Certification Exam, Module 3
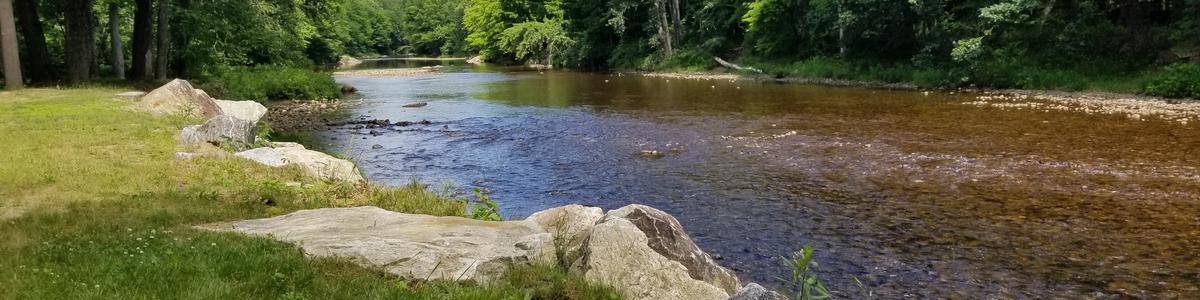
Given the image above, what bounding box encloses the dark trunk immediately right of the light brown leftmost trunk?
[13,0,54,83]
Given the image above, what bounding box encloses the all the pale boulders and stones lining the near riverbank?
[126,79,782,300]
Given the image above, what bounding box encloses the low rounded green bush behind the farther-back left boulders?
[204,66,341,102]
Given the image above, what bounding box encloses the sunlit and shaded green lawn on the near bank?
[0,88,616,299]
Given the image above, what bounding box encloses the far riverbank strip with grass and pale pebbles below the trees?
[646,58,1200,98]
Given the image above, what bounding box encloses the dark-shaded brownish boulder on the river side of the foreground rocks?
[605,204,742,294]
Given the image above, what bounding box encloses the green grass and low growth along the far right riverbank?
[653,52,1200,98]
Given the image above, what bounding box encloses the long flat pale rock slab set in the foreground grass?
[202,206,553,282]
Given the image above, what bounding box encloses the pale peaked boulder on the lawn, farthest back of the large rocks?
[138,79,221,118]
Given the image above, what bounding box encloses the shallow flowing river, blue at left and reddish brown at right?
[320,62,1200,299]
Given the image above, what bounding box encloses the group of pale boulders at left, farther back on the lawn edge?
[125,79,365,182]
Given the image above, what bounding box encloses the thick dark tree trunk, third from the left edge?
[62,0,96,84]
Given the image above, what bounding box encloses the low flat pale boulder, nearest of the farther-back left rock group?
[234,143,366,182]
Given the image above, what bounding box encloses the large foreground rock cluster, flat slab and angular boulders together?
[202,204,784,300]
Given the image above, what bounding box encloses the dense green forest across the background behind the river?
[2,0,1200,96]
